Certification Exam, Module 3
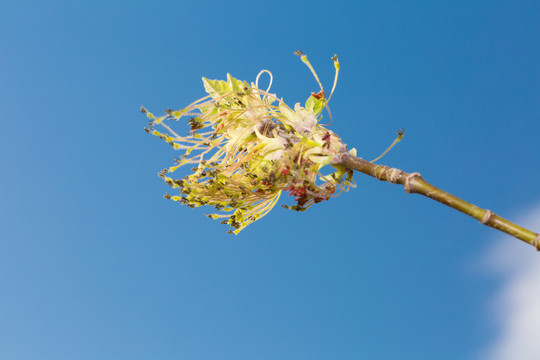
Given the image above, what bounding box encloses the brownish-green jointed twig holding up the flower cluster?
[341,154,540,250]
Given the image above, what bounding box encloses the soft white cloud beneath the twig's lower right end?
[483,202,540,360]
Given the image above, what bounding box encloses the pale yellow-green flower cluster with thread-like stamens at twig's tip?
[141,53,355,234]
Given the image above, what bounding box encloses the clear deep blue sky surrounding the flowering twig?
[0,0,540,360]
